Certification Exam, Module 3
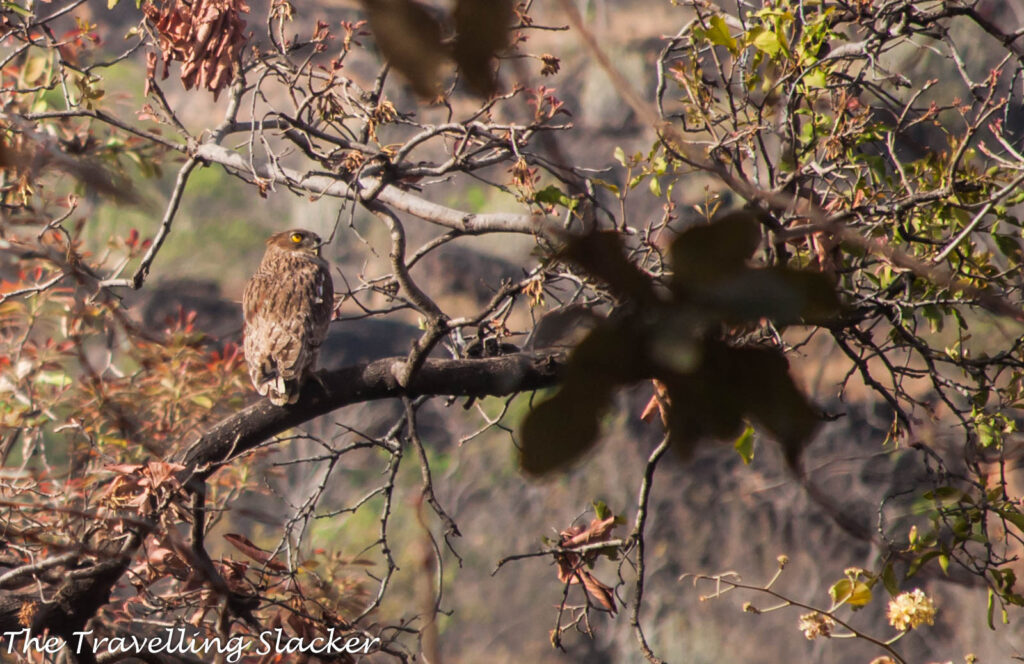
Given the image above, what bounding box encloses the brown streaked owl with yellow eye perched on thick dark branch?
[242,230,334,406]
